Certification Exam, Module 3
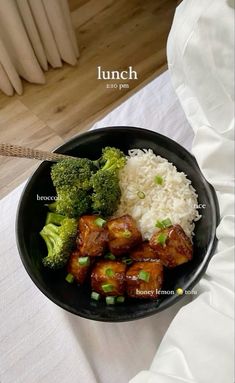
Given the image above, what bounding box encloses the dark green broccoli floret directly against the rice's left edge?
[92,169,121,217]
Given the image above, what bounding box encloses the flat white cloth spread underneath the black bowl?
[0,72,193,383]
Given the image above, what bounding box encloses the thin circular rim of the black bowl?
[15,125,220,323]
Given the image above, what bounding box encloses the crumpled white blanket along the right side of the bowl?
[131,0,234,383]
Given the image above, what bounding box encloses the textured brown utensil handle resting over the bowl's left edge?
[0,144,76,162]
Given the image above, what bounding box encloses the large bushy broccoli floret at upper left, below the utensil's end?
[49,158,95,218]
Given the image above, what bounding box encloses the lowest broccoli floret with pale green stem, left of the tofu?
[40,213,77,269]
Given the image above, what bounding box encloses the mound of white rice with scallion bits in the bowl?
[115,149,200,239]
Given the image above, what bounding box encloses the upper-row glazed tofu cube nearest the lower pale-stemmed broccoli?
[77,215,108,257]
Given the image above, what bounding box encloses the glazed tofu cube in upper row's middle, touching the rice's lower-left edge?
[106,214,142,256]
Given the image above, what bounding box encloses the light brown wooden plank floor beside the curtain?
[0,0,177,198]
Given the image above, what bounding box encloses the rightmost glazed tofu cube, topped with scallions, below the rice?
[150,225,193,268]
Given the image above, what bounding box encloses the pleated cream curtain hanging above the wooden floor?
[0,0,79,96]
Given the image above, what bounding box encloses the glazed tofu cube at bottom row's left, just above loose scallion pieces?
[91,260,126,296]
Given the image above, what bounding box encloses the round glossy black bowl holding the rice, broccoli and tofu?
[16,127,219,322]
